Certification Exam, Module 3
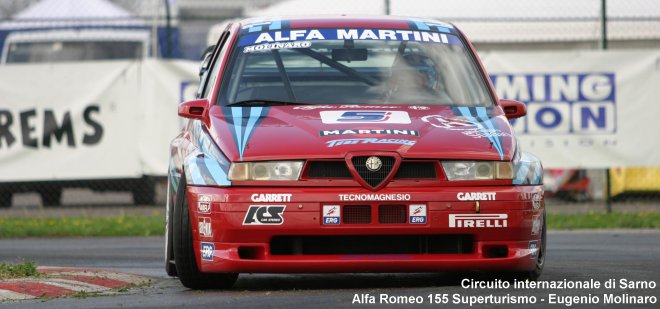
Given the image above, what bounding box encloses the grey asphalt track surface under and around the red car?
[0,230,660,309]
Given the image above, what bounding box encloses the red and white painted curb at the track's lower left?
[0,266,150,301]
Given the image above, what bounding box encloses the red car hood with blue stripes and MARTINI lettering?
[209,105,515,161]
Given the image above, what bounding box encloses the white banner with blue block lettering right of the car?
[480,50,660,168]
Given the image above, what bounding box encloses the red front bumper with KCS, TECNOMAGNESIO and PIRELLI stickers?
[187,186,544,273]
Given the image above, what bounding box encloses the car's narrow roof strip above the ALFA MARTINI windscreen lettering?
[239,15,455,32]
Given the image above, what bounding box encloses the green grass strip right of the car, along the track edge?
[546,212,660,230]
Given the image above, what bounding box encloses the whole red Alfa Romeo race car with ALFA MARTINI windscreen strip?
[166,16,546,289]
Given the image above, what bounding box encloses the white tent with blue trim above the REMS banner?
[0,0,155,64]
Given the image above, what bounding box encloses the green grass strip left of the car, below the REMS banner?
[0,214,165,238]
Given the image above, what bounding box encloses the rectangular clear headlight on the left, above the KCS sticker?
[228,161,303,180]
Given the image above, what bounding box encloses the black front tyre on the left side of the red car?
[172,177,238,290]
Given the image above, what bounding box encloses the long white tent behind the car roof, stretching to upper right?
[246,0,660,43]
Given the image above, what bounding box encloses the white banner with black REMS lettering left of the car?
[0,60,199,182]
